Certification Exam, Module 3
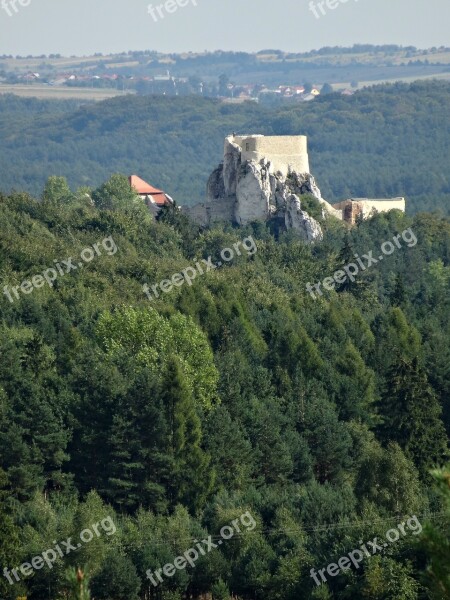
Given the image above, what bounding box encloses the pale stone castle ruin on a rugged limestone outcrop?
[183,134,405,241]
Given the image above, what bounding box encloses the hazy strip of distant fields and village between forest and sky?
[0,44,450,104]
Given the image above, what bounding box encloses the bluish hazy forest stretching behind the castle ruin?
[0,82,450,214]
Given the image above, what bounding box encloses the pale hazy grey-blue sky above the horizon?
[0,0,450,55]
